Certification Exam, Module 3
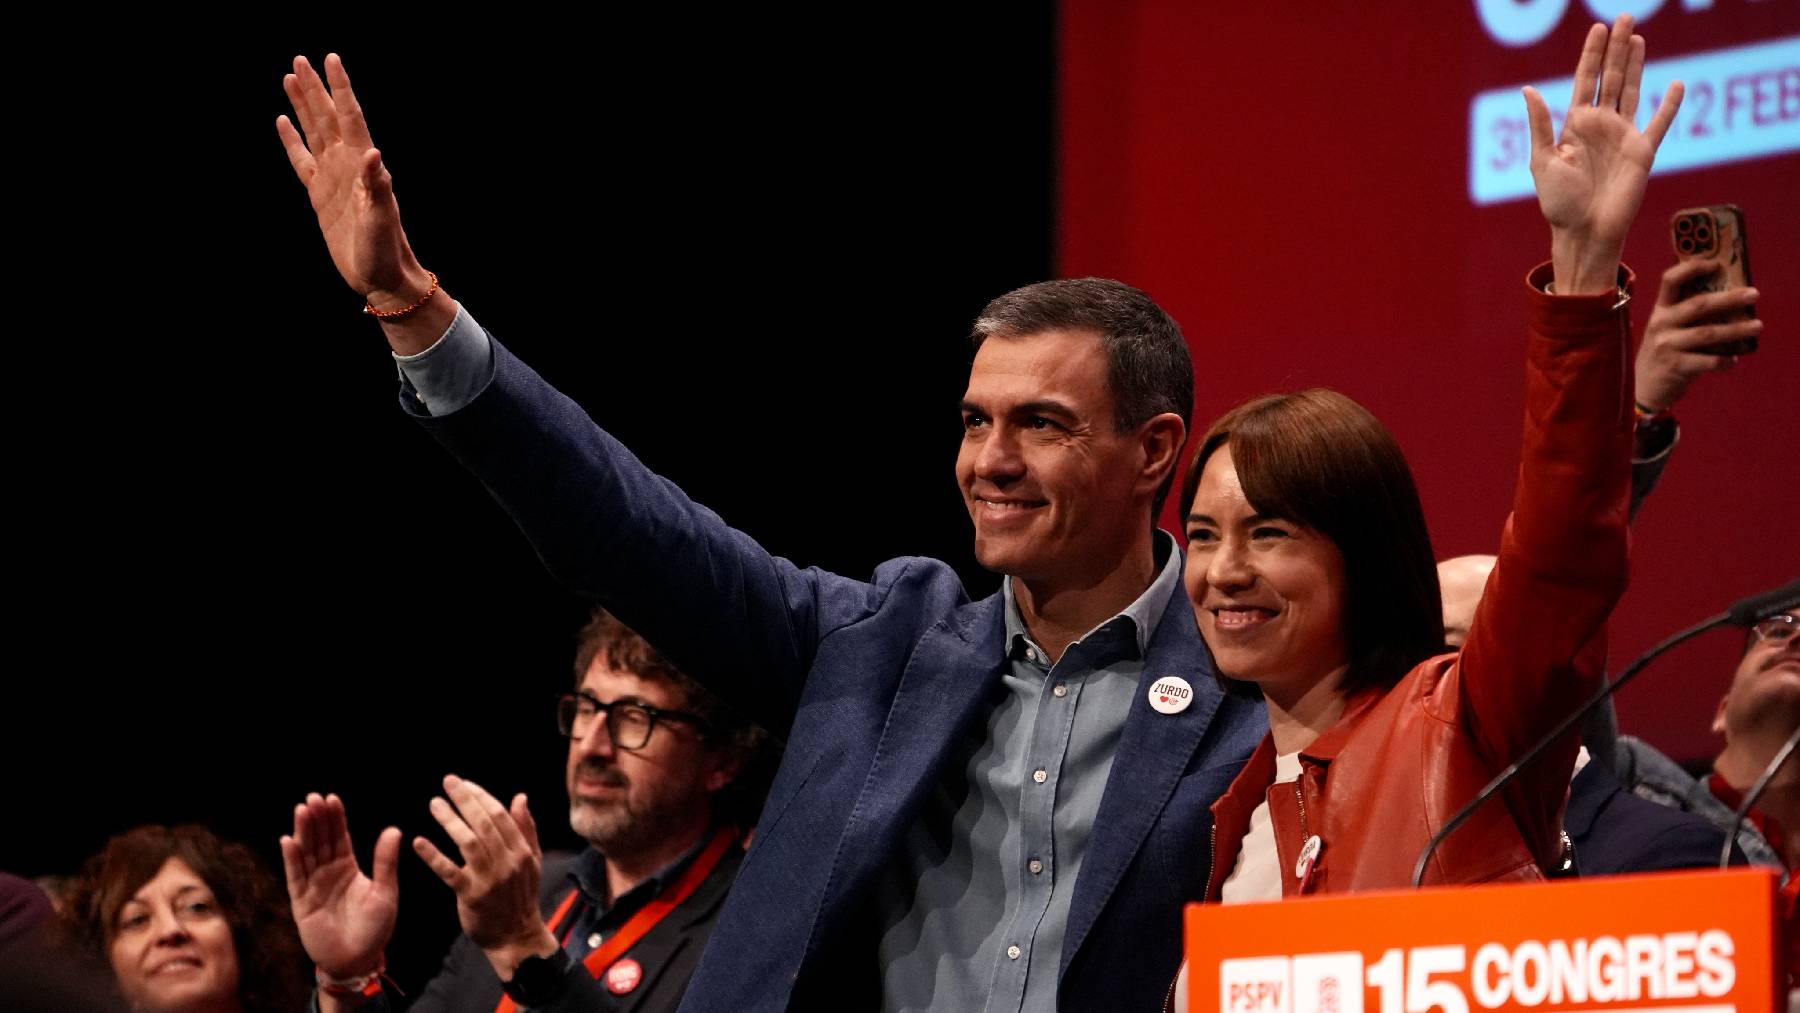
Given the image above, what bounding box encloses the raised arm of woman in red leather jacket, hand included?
[1458,16,1681,862]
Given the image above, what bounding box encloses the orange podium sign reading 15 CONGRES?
[1186,869,1786,1013]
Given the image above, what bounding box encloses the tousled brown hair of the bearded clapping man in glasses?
[574,608,781,828]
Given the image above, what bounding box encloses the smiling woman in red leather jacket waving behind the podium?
[1183,16,1681,903]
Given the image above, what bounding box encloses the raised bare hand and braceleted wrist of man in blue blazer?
[275,52,457,354]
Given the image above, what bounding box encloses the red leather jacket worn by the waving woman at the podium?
[1206,264,1633,900]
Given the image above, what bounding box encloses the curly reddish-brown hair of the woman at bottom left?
[61,824,311,1013]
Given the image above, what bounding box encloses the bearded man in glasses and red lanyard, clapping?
[281,610,770,1013]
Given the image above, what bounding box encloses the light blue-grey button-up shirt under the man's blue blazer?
[878,531,1181,1013]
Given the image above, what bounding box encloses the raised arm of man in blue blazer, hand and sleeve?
[275,54,849,731]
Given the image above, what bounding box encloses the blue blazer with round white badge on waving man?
[412,342,1267,1013]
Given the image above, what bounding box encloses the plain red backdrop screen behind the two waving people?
[1058,0,1800,759]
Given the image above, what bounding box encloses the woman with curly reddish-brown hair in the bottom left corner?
[61,824,311,1013]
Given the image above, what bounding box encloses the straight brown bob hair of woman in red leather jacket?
[1181,389,1444,696]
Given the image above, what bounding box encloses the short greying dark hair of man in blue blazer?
[968,277,1193,516]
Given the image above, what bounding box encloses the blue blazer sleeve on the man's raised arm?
[400,342,878,734]
